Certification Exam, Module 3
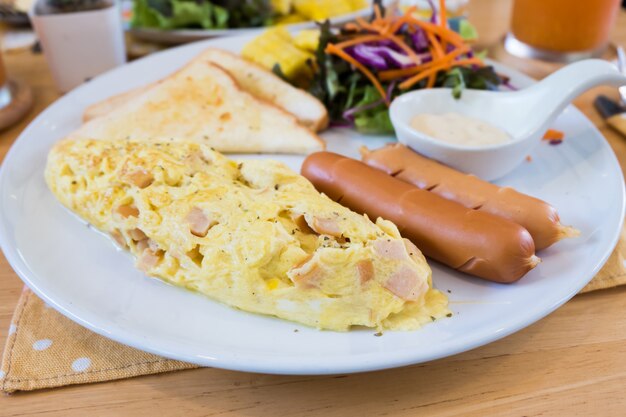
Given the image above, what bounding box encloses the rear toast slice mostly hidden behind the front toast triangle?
[83,48,328,132]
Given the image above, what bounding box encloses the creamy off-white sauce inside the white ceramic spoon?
[410,113,511,148]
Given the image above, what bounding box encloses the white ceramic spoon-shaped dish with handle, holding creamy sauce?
[389,59,626,181]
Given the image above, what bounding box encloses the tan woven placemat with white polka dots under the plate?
[0,226,626,393]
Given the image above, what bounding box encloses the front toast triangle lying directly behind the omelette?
[70,60,324,154]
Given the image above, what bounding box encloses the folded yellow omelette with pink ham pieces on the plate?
[45,139,449,331]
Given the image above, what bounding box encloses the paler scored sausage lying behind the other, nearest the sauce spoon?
[361,143,580,250]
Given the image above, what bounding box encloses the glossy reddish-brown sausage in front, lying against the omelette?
[302,152,540,283]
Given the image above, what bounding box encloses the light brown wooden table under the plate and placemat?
[0,0,626,417]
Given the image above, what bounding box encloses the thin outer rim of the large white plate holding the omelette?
[0,34,626,375]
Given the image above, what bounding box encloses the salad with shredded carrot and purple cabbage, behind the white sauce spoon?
[243,0,505,133]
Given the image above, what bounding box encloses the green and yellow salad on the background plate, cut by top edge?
[131,0,367,29]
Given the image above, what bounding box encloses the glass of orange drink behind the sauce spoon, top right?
[505,0,621,62]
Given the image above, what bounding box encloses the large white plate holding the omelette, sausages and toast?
[0,37,624,374]
